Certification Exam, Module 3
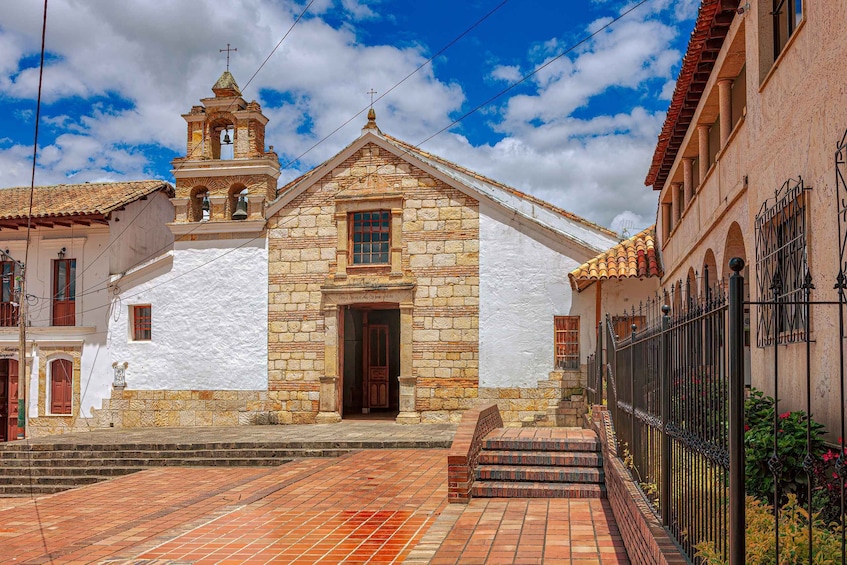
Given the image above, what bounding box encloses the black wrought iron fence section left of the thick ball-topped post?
[595,285,729,556]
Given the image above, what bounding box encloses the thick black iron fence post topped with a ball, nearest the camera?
[728,257,745,565]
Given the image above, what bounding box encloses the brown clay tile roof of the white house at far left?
[0,180,174,229]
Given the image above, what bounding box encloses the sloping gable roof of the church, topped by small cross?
[274,124,617,256]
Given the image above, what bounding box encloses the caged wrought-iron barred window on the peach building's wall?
[756,179,808,347]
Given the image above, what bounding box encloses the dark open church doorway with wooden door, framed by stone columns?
[340,304,400,418]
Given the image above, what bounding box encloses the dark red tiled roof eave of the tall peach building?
[644,0,739,190]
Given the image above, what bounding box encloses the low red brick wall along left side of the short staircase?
[447,404,503,503]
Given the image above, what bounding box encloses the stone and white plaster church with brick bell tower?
[1,71,618,434]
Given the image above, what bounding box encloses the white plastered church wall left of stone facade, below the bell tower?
[109,237,268,390]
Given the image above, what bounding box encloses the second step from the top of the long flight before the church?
[0,448,353,465]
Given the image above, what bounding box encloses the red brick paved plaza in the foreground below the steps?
[0,440,628,564]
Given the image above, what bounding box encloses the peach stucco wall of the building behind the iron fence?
[658,0,847,437]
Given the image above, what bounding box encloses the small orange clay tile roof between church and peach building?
[568,225,663,291]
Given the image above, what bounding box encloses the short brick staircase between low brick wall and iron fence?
[471,428,606,498]
